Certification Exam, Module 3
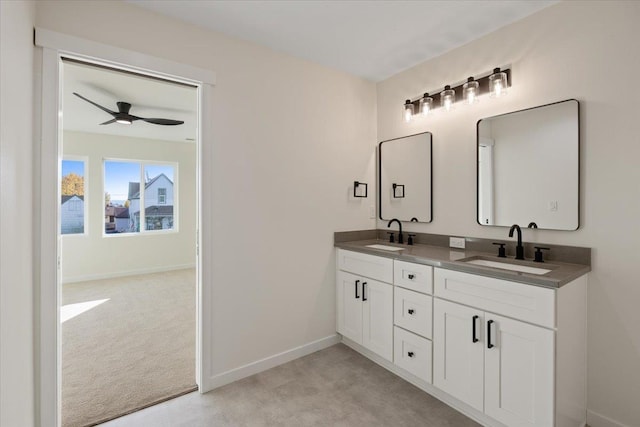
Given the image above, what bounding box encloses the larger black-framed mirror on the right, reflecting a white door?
[477,99,580,230]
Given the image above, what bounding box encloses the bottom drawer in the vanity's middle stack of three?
[393,326,432,384]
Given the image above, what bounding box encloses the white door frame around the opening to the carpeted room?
[34,28,216,427]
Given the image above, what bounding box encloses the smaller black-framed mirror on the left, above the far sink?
[378,132,432,222]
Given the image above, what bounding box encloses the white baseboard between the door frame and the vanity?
[200,334,340,393]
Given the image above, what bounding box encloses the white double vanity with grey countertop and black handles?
[335,230,590,427]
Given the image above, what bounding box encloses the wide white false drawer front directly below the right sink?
[433,268,556,328]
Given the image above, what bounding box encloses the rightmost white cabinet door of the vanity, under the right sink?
[485,313,554,427]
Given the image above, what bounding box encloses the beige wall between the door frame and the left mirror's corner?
[36,1,377,402]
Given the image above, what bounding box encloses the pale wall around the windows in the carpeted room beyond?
[62,131,196,283]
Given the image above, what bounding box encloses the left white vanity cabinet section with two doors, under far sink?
[337,249,393,361]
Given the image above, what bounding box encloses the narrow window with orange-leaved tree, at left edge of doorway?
[60,159,86,234]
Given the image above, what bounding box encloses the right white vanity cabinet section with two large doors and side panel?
[433,268,586,427]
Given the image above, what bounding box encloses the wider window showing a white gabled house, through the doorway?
[104,160,177,234]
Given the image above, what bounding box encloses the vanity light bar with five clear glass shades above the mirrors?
[402,68,511,122]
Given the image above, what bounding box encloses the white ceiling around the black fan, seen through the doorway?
[62,61,197,142]
